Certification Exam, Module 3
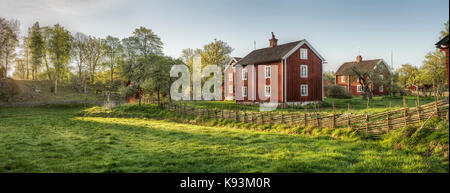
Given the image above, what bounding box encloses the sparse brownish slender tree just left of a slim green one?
[86,36,105,85]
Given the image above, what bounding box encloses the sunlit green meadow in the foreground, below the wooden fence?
[0,108,448,172]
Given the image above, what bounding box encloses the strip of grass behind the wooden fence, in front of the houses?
[179,96,440,113]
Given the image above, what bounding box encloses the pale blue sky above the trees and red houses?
[0,0,449,70]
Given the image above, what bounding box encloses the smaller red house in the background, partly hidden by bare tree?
[335,56,389,95]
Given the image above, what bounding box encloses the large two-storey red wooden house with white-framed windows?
[225,33,325,104]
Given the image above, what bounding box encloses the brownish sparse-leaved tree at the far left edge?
[0,18,19,77]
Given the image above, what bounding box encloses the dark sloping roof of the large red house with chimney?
[237,40,302,65]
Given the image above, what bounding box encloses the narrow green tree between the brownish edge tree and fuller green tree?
[28,22,44,80]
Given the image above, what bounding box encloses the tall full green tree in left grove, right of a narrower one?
[49,24,72,94]
